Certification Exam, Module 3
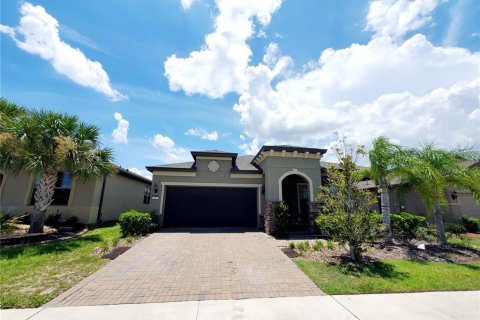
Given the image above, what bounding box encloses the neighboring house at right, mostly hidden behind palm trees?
[361,161,480,223]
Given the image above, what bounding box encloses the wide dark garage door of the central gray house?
[163,187,257,228]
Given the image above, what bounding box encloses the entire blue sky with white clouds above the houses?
[0,0,480,178]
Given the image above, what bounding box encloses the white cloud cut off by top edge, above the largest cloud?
[367,0,440,38]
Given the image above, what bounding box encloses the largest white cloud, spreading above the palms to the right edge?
[234,35,480,149]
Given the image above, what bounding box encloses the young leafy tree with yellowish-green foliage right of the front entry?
[316,138,384,261]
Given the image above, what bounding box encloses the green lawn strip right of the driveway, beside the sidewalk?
[294,259,480,294]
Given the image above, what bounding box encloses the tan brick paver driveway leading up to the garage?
[47,231,323,306]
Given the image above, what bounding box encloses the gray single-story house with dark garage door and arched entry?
[147,146,326,233]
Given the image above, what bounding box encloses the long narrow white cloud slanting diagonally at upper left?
[0,2,127,101]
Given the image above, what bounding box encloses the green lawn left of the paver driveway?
[0,226,120,308]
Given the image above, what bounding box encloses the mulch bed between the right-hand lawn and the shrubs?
[282,242,480,264]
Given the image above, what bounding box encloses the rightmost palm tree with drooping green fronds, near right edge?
[397,142,480,244]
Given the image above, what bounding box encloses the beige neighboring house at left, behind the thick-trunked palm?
[0,167,151,224]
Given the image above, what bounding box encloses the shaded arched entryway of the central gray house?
[279,172,312,231]
